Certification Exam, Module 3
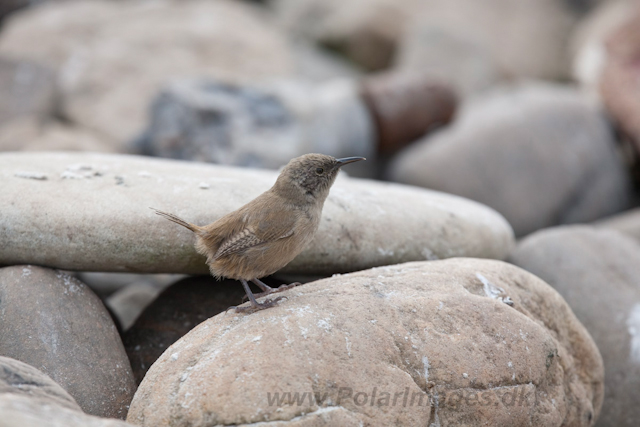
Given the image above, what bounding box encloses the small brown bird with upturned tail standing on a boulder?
[156,154,365,312]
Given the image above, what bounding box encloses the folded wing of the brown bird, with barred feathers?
[215,202,296,258]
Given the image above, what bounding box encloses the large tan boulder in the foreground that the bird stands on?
[127,259,603,427]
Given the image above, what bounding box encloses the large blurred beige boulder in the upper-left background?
[0,0,294,149]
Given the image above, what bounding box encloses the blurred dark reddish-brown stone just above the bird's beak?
[361,72,458,155]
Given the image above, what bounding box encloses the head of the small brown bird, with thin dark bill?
[274,154,365,202]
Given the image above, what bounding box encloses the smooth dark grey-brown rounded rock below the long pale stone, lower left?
[0,266,135,418]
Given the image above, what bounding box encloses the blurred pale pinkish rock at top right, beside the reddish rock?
[570,0,636,97]
